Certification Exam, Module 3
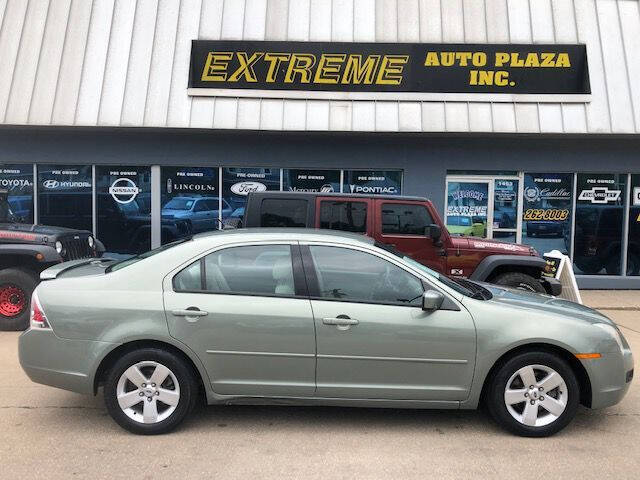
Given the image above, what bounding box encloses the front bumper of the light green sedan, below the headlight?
[581,349,633,408]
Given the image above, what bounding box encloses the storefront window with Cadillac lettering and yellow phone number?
[522,173,573,255]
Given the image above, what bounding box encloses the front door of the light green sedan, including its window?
[301,244,476,401]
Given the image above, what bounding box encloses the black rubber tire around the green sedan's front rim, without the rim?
[485,352,580,437]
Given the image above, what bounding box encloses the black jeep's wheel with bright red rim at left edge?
[0,268,38,331]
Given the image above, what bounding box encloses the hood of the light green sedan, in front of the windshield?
[475,282,613,325]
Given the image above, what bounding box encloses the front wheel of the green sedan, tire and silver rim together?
[486,352,580,437]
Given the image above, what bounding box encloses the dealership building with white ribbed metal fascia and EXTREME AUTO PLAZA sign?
[0,0,640,288]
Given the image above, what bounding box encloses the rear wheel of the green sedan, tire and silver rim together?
[104,348,198,435]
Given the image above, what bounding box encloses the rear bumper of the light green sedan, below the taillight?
[18,329,116,394]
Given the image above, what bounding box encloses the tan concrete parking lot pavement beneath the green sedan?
[0,311,640,479]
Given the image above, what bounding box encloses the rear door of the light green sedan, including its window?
[164,243,316,396]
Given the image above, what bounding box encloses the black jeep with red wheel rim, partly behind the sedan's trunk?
[0,190,104,330]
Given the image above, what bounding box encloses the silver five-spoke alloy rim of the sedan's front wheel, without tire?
[504,365,568,427]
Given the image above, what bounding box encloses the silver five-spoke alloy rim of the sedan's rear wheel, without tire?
[116,361,180,424]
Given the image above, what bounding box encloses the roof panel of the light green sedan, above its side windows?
[193,228,375,245]
